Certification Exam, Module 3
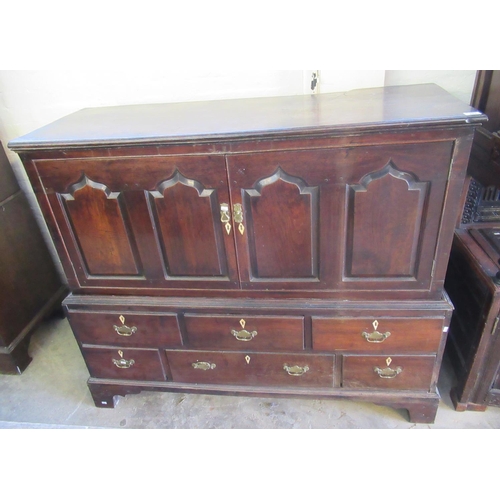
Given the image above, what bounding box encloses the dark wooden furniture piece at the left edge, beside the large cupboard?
[0,144,66,374]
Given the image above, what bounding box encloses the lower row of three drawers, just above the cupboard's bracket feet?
[82,347,436,390]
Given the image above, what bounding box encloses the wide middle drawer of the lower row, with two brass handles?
[167,351,334,387]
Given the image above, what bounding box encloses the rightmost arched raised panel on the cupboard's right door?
[345,161,428,280]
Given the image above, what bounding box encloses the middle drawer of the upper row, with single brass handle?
[185,314,304,351]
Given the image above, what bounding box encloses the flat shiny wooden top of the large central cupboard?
[9,84,487,151]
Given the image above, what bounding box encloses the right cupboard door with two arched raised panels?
[228,141,453,291]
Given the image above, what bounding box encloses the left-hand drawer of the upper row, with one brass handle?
[68,312,182,347]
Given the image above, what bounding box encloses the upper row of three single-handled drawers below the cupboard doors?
[69,312,443,352]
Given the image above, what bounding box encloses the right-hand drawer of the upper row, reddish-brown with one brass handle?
[312,317,444,352]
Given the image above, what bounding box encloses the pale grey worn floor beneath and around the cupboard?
[0,319,500,429]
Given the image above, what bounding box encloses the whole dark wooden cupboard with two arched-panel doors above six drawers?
[10,84,485,422]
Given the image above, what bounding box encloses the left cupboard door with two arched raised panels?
[35,156,239,289]
